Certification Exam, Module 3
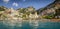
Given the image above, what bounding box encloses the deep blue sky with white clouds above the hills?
[0,0,54,9]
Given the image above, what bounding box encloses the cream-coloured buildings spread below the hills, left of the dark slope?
[1,7,39,20]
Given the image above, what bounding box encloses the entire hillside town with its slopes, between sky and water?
[0,1,60,20]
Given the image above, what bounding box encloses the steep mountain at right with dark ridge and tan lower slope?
[37,0,60,18]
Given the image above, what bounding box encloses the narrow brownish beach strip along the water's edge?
[0,19,60,22]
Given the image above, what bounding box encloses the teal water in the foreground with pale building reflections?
[0,21,60,29]
